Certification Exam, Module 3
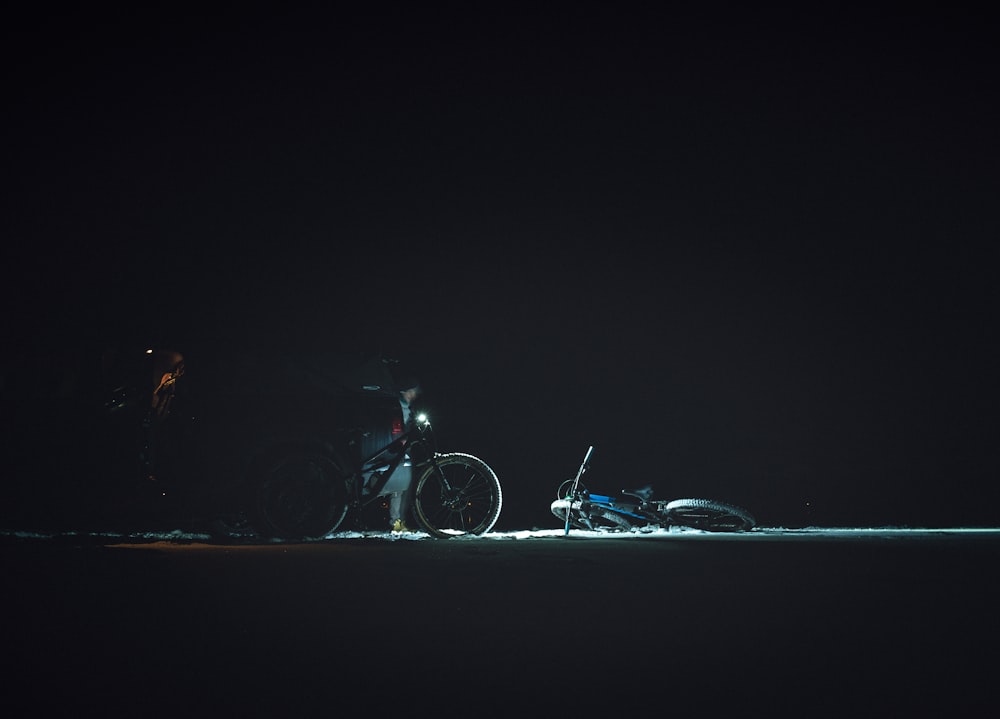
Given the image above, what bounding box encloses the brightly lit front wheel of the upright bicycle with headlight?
[413,452,503,539]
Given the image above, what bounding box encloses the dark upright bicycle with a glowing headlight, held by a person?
[256,415,503,539]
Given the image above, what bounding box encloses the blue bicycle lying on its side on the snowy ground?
[551,447,757,534]
